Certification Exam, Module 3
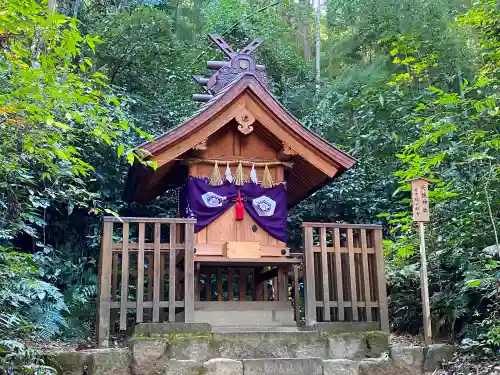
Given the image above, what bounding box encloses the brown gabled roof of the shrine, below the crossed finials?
[124,73,356,205]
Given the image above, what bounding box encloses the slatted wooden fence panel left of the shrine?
[96,217,195,347]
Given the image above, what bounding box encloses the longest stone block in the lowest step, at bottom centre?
[243,358,323,375]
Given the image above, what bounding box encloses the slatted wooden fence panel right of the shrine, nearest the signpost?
[302,223,389,331]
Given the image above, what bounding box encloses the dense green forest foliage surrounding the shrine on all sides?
[0,0,500,362]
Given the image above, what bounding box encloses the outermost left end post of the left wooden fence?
[96,221,113,348]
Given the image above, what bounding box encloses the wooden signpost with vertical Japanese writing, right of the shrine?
[409,178,432,345]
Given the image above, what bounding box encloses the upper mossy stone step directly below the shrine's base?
[130,328,389,363]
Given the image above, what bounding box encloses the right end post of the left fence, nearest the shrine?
[184,223,194,323]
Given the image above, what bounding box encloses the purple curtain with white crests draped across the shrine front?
[179,177,287,242]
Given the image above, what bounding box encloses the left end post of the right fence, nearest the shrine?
[303,226,317,326]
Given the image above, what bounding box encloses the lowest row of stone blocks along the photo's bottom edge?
[46,345,453,375]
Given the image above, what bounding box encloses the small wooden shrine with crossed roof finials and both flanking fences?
[95,35,385,346]
